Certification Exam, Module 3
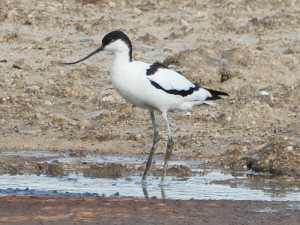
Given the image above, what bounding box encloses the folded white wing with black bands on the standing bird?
[146,63,197,91]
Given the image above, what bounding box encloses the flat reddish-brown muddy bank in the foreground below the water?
[0,196,300,225]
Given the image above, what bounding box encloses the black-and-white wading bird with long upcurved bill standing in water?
[63,30,228,186]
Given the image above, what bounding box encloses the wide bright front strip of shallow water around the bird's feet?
[0,170,300,201]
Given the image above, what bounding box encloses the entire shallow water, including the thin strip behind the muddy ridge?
[0,150,300,201]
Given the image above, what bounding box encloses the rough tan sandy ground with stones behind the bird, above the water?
[0,0,300,224]
